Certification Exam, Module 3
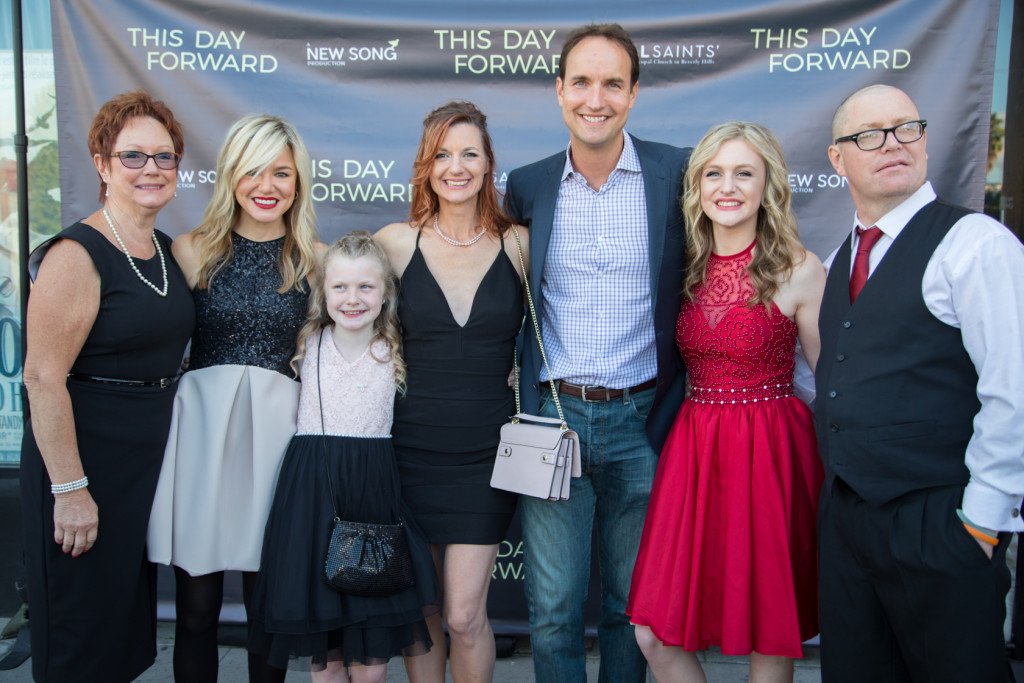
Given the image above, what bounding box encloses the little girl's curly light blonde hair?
[292,230,406,394]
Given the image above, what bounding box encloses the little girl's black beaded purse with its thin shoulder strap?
[316,330,416,597]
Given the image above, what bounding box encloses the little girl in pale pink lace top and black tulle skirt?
[249,230,443,683]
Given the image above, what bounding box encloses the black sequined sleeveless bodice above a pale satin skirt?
[188,232,308,377]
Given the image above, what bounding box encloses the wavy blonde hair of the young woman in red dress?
[682,121,805,306]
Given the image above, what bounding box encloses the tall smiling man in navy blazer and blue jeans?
[506,25,689,683]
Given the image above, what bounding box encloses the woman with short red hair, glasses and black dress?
[22,91,195,683]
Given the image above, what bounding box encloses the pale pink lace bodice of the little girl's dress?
[298,328,394,436]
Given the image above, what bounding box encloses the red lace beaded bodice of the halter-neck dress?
[676,245,797,403]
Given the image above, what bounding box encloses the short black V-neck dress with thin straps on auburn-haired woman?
[391,236,523,545]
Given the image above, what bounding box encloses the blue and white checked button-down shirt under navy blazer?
[541,132,657,389]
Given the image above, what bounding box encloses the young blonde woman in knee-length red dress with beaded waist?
[627,122,825,683]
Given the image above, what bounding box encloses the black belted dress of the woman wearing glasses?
[22,223,196,683]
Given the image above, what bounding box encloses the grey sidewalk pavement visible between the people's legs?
[0,618,821,683]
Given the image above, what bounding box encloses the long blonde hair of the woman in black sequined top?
[193,114,316,294]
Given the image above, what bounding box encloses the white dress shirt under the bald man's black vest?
[825,182,1024,531]
